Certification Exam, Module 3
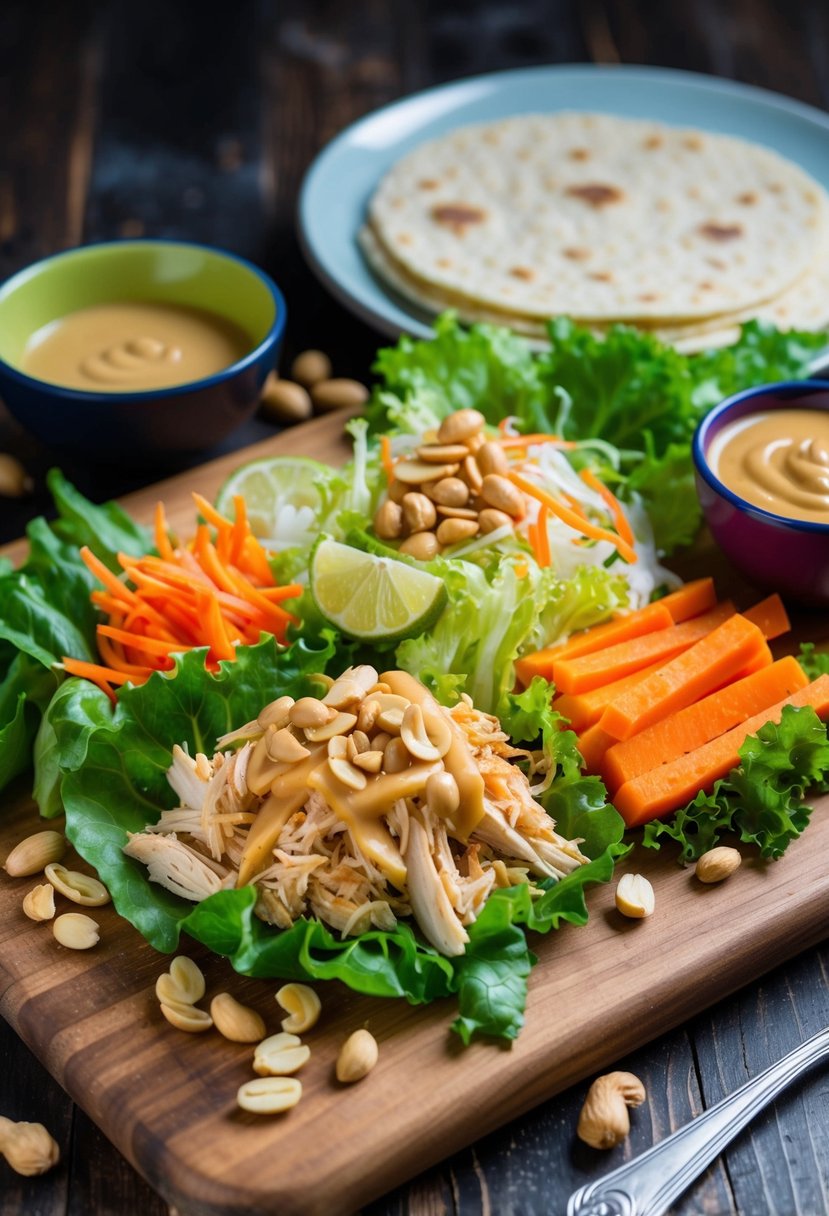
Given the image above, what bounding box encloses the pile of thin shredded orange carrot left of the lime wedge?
[64,494,303,699]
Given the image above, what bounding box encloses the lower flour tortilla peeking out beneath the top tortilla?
[359,227,829,354]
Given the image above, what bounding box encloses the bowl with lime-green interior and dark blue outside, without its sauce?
[0,241,286,463]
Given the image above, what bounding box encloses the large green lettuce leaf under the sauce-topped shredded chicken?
[56,631,621,1040]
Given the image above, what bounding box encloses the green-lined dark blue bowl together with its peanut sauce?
[0,240,286,465]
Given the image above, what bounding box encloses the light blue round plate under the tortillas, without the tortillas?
[299,64,829,338]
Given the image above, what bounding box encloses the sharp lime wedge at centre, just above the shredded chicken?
[310,539,446,642]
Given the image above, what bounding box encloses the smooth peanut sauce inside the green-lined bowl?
[21,300,253,393]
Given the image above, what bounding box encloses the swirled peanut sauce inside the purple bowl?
[709,410,829,524]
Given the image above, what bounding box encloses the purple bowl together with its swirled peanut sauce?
[693,379,829,606]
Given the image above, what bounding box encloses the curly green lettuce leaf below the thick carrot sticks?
[643,705,829,862]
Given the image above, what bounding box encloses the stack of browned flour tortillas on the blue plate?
[360,113,829,350]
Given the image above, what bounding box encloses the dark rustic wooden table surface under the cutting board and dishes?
[0,0,829,1216]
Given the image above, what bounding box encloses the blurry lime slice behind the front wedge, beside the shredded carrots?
[216,456,337,545]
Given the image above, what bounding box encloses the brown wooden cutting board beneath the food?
[0,416,829,1216]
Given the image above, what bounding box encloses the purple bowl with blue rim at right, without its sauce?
[693,381,829,604]
